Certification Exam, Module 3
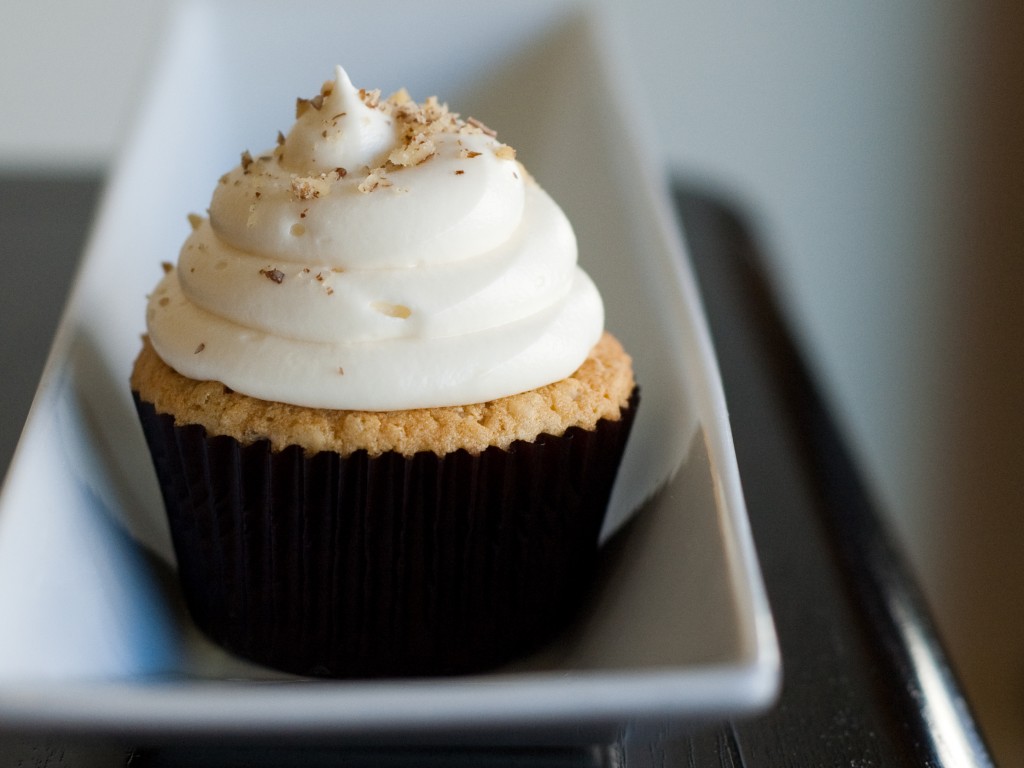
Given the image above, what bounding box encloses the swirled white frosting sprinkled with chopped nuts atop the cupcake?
[147,68,604,411]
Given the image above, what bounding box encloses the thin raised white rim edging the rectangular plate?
[0,2,781,737]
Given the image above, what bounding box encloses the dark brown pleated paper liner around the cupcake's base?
[135,391,638,677]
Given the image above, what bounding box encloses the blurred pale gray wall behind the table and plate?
[0,0,1024,765]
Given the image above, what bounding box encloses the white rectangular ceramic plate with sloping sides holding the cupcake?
[0,1,779,743]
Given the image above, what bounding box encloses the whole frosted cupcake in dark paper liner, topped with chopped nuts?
[131,68,637,677]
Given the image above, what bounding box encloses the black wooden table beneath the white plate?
[0,174,991,768]
